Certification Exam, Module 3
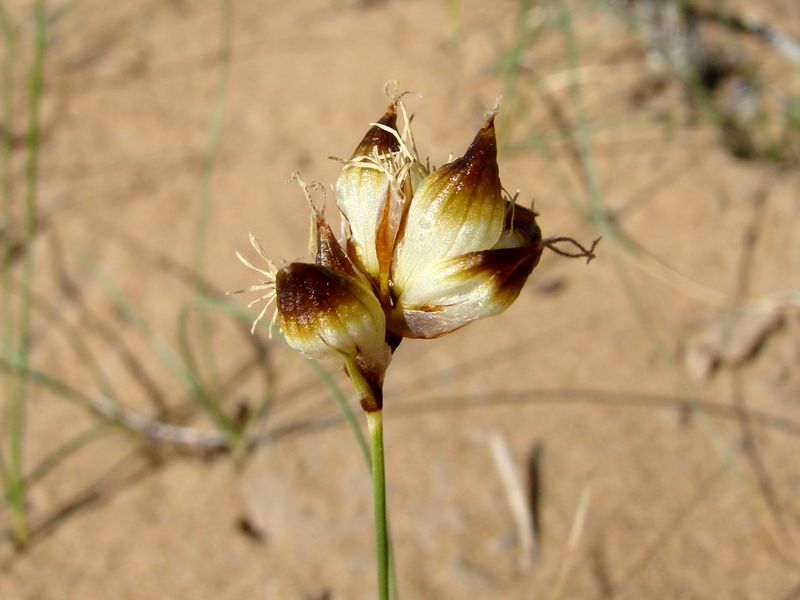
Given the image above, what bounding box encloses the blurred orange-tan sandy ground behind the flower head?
[0,0,800,600]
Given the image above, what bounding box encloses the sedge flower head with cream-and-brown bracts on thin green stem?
[230,86,596,600]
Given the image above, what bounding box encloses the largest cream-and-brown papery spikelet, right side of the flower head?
[380,115,543,338]
